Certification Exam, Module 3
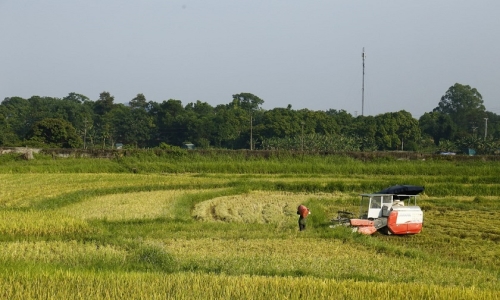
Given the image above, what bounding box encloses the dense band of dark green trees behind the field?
[0,83,500,154]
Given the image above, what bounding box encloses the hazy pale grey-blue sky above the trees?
[0,0,500,118]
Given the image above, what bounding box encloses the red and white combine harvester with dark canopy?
[333,185,424,235]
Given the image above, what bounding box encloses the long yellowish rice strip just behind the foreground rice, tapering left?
[146,238,500,288]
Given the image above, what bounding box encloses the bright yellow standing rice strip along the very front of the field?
[0,272,498,300]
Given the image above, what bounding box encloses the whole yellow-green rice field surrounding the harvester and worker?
[0,156,500,299]
